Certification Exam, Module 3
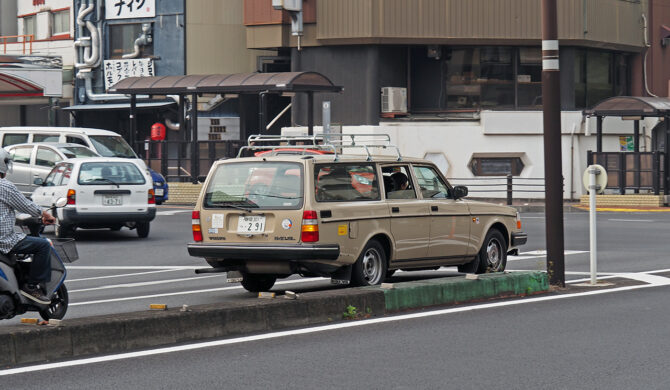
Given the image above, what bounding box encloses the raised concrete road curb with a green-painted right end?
[0,272,549,366]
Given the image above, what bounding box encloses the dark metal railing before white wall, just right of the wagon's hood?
[449,175,545,205]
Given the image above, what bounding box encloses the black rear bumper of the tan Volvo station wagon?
[188,242,340,260]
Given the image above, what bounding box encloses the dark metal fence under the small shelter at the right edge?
[587,151,665,195]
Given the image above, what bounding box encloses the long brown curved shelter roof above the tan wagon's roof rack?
[109,72,342,95]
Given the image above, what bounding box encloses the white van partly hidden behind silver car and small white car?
[0,126,139,160]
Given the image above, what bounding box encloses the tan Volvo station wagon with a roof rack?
[188,136,527,292]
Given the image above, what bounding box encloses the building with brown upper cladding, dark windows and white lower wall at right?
[245,0,670,199]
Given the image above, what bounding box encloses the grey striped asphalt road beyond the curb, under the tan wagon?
[0,207,670,326]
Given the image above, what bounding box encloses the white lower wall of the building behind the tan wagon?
[283,111,657,200]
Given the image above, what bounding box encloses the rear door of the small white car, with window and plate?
[71,160,151,213]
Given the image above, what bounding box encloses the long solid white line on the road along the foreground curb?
[5,272,670,376]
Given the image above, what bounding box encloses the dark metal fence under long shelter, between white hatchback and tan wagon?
[143,141,242,182]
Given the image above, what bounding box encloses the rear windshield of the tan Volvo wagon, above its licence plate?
[205,162,303,209]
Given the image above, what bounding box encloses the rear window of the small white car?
[77,161,146,185]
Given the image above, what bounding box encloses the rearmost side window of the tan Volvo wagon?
[314,164,380,202]
